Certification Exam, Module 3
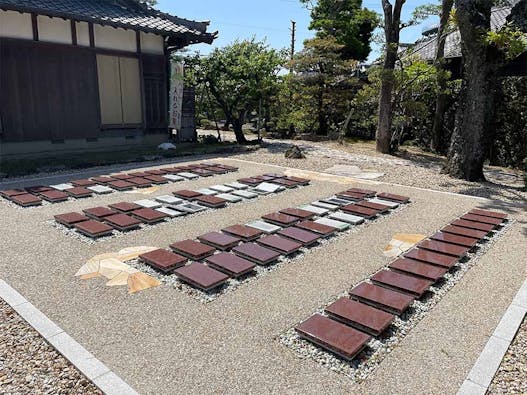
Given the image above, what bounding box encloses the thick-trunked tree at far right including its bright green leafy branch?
[444,0,527,181]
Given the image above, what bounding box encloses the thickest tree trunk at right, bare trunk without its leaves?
[444,0,500,181]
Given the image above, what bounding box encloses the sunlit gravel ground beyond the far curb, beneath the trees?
[230,140,527,206]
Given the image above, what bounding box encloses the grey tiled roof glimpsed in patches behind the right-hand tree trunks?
[404,3,512,60]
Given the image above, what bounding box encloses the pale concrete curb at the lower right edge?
[457,280,527,395]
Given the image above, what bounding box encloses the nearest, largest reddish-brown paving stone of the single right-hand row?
[295,314,371,361]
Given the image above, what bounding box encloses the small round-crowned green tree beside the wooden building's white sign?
[186,39,285,144]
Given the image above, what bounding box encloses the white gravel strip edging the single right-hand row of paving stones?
[279,221,514,383]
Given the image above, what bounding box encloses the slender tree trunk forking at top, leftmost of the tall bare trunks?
[376,0,405,154]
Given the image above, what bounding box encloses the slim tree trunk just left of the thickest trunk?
[430,0,454,153]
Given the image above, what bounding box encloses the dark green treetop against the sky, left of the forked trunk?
[300,0,379,61]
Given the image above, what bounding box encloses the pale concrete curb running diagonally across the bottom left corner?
[0,279,137,395]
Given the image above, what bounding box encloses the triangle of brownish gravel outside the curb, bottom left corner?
[0,299,102,394]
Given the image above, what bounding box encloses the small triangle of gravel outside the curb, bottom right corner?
[489,318,527,394]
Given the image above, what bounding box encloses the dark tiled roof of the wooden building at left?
[0,0,217,45]
